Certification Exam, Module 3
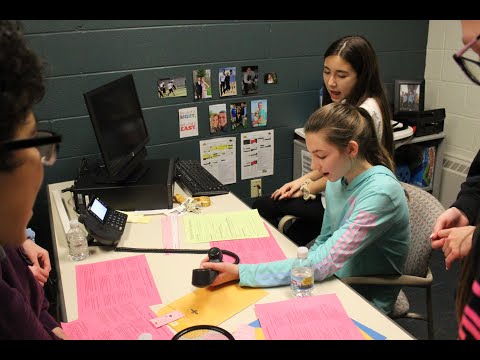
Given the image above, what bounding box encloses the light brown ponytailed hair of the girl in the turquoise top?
[304,103,395,172]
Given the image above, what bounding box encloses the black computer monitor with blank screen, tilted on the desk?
[83,74,149,183]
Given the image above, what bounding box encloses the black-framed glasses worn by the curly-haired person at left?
[0,130,62,166]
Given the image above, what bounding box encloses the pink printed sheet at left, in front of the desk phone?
[75,255,162,318]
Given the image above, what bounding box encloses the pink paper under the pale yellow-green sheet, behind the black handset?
[210,224,287,264]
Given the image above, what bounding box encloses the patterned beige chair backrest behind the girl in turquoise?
[402,182,445,277]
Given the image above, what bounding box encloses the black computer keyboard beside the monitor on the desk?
[175,160,229,196]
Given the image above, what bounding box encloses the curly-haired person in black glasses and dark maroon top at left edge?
[0,20,67,340]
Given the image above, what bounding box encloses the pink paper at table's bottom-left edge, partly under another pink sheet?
[62,303,173,340]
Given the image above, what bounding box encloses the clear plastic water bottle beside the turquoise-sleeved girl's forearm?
[290,246,314,297]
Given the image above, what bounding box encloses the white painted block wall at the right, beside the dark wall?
[425,20,480,206]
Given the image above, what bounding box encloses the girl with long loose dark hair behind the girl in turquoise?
[252,36,394,245]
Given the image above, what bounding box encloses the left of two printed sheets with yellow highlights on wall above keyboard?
[199,137,237,185]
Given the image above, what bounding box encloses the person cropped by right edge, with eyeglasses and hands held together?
[430,20,480,340]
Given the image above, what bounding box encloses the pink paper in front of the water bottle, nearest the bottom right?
[255,294,364,340]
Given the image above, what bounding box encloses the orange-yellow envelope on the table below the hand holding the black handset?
[157,284,268,332]
